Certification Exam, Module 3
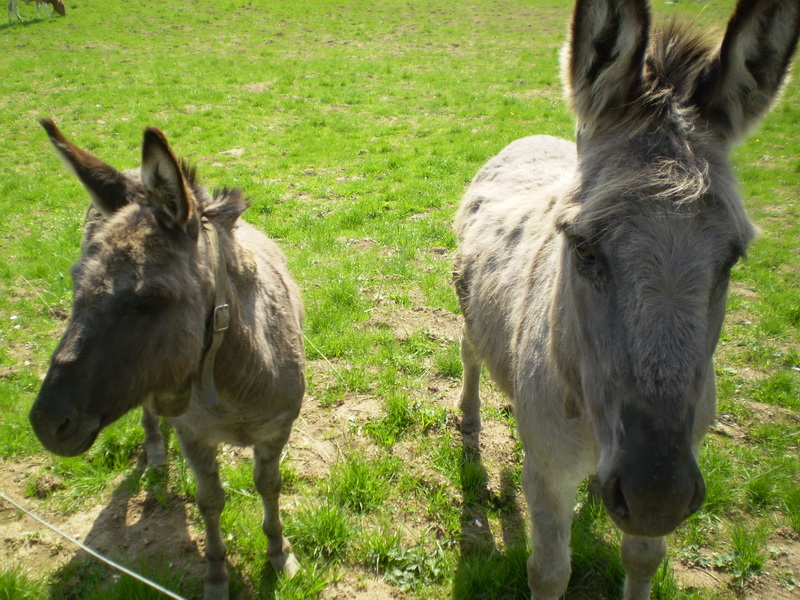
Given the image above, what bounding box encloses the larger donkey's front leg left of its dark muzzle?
[522,455,580,600]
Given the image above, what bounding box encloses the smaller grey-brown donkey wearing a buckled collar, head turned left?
[30,119,305,600]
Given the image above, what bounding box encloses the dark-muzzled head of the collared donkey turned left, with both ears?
[30,120,223,456]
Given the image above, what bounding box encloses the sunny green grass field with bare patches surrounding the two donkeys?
[0,0,800,600]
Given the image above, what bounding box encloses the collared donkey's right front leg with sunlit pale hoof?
[253,436,300,577]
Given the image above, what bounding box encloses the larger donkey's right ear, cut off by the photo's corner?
[695,0,800,143]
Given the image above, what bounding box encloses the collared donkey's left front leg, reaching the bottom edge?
[178,430,229,600]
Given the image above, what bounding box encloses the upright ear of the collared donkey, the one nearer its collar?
[142,127,197,230]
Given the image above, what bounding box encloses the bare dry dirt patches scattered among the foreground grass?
[0,305,800,600]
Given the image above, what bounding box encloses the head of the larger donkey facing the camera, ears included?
[556,0,800,536]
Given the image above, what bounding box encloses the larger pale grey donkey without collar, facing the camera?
[454,0,800,600]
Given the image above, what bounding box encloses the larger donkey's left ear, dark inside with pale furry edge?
[563,0,650,133]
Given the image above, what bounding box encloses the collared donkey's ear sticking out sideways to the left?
[39,119,129,215]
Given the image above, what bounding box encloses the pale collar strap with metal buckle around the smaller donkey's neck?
[199,217,230,406]
